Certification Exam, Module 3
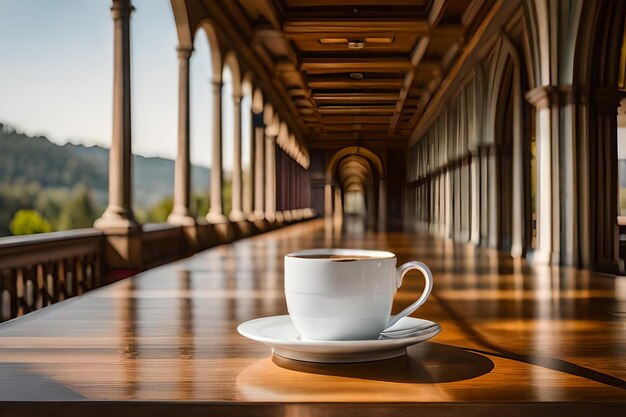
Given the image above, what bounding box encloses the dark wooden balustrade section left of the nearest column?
[0,229,104,321]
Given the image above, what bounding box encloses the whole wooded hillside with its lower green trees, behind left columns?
[0,123,210,236]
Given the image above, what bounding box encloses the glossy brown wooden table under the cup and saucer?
[0,220,626,417]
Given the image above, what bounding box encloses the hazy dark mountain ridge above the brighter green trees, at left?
[0,123,210,209]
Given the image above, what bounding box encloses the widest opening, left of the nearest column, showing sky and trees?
[0,2,112,236]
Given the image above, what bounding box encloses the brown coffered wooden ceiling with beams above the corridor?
[238,0,492,146]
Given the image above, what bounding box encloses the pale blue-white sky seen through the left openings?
[0,0,244,170]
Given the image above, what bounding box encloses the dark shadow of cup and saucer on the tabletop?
[272,342,494,384]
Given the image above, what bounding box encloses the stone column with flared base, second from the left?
[167,48,196,226]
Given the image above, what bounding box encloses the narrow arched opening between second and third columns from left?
[189,22,221,219]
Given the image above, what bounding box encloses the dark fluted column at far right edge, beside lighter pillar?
[574,1,626,273]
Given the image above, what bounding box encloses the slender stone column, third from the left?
[207,81,227,223]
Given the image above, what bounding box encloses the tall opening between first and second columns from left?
[131,0,178,223]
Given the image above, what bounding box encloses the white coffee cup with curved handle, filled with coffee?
[285,249,433,340]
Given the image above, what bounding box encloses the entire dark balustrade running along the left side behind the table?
[0,209,316,322]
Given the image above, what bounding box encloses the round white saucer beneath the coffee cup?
[237,315,441,363]
